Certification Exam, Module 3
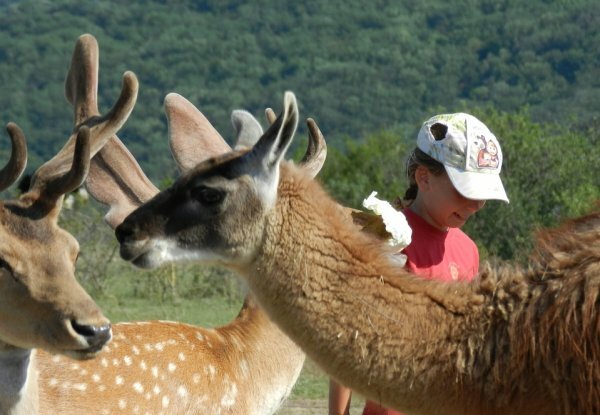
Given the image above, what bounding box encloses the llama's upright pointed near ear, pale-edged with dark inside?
[248,91,298,174]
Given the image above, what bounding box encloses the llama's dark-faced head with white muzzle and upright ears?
[116,92,298,268]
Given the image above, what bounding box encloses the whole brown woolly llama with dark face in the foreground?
[105,91,600,415]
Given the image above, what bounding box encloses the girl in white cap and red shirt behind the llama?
[329,113,508,415]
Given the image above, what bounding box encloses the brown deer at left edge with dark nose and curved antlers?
[0,57,137,415]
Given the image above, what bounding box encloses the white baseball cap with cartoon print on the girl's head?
[417,112,508,203]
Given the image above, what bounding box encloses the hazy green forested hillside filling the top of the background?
[0,0,600,179]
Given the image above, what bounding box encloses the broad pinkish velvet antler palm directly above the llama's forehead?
[164,93,231,171]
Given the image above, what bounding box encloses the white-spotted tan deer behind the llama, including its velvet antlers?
[38,34,326,415]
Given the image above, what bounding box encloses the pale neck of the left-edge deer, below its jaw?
[0,343,38,415]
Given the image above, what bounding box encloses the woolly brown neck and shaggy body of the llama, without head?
[243,165,600,415]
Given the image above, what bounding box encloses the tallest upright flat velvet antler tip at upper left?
[65,34,100,125]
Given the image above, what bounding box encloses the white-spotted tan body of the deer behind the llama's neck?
[35,298,304,415]
